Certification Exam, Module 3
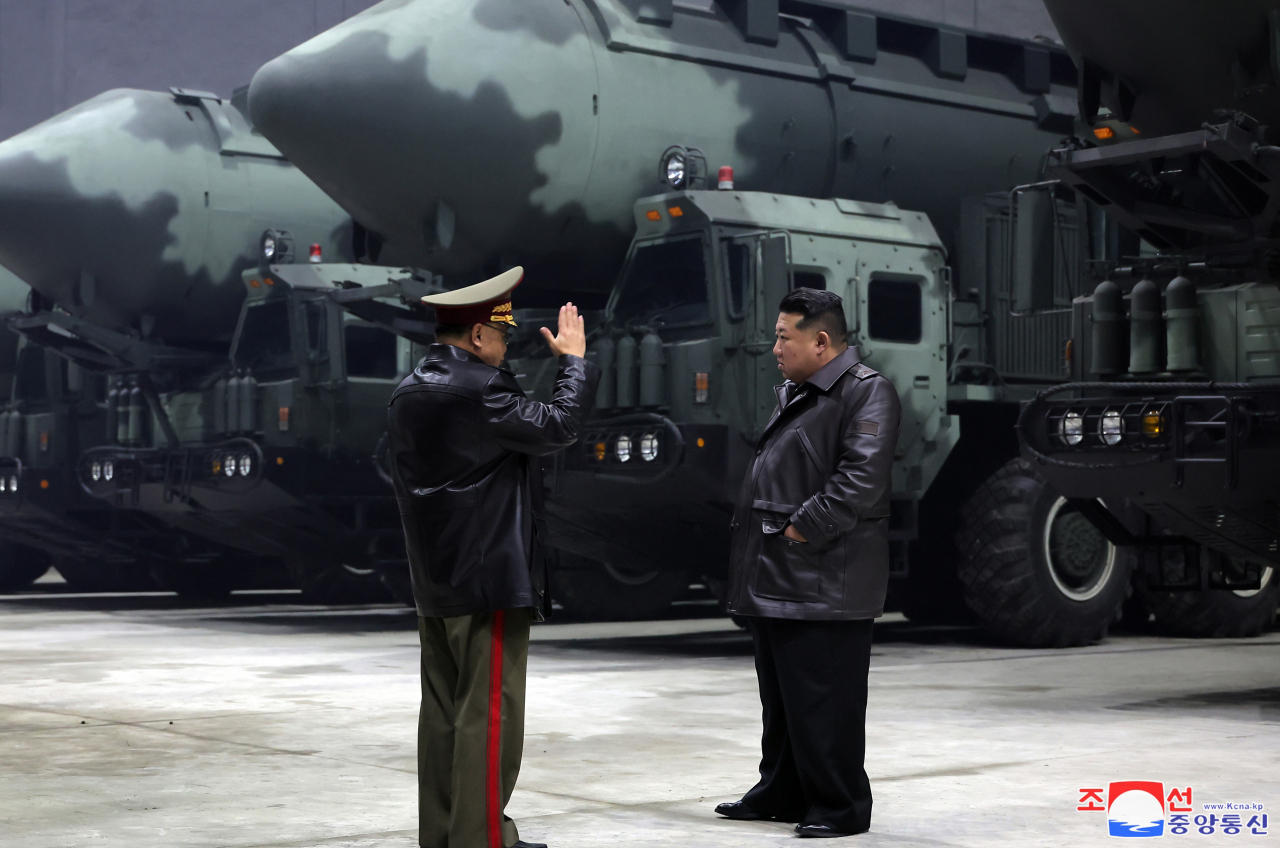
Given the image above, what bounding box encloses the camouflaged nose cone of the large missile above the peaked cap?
[250,0,609,286]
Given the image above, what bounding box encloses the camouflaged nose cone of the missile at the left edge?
[0,91,212,335]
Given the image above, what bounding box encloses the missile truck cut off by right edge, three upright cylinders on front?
[1020,0,1280,637]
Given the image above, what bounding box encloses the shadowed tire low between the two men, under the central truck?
[552,552,691,621]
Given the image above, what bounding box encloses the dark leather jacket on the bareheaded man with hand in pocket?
[728,347,902,620]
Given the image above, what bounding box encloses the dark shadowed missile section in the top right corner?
[1044,0,1280,140]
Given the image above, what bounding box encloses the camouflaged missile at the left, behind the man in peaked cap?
[0,90,352,347]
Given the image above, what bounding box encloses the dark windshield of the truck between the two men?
[613,236,712,325]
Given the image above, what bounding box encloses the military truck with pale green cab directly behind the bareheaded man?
[473,179,1152,646]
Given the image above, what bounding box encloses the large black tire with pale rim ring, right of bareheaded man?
[956,459,1133,648]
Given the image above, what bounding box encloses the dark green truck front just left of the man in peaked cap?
[77,262,433,603]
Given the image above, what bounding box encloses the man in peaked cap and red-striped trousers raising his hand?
[388,268,599,848]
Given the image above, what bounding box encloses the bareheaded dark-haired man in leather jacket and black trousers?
[716,288,901,836]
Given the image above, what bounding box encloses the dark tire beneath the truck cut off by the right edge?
[1139,548,1280,639]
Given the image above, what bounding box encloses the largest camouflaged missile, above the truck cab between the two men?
[250,0,1075,306]
